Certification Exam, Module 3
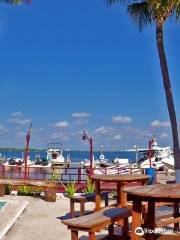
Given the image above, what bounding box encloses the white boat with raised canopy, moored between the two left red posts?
[47,143,65,166]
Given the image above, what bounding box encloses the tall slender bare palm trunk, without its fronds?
[156,21,180,182]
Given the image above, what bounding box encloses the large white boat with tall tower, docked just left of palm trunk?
[138,138,172,170]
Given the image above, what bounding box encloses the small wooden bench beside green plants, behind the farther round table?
[70,192,109,218]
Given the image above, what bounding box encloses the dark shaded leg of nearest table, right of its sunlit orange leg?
[145,200,155,240]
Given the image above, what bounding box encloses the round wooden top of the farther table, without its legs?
[91,174,150,182]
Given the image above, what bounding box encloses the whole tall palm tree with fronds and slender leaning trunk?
[106,0,180,182]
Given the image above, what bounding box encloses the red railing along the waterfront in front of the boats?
[0,164,154,183]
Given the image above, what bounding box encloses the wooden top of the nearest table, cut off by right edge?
[124,184,180,201]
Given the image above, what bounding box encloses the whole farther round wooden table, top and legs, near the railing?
[91,174,150,211]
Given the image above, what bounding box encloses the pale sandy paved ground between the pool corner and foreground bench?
[3,196,109,240]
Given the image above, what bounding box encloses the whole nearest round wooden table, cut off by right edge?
[124,184,180,240]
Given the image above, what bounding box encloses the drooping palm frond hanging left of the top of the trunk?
[127,1,153,30]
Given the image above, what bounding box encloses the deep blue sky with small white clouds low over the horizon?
[0,0,180,150]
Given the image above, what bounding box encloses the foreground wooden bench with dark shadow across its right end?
[62,207,131,240]
